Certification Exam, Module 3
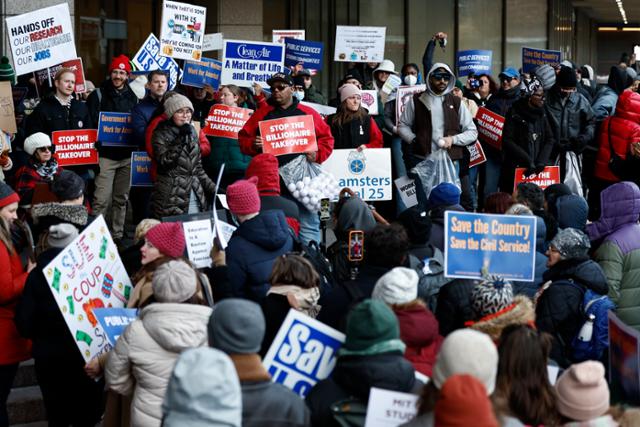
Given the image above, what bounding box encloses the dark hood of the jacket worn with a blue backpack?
[542,258,609,295]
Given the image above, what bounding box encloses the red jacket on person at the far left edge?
[0,243,31,365]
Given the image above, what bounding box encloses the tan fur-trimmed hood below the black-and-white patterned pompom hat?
[466,295,536,342]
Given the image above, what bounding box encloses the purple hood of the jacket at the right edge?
[587,181,640,241]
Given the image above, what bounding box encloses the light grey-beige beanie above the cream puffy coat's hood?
[151,260,198,303]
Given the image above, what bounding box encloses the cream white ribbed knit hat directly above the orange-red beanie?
[431,329,498,395]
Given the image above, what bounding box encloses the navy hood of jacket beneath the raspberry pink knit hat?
[233,210,291,251]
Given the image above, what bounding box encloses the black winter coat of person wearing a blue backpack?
[536,258,609,367]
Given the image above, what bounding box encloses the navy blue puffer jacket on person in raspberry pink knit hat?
[226,210,293,303]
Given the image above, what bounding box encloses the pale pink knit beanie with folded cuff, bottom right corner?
[556,360,609,421]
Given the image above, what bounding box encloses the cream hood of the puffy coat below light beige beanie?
[140,303,212,353]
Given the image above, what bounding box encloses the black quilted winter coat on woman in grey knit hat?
[151,119,215,219]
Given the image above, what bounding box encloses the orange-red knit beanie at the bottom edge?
[434,374,499,427]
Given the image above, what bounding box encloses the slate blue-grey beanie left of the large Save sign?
[208,298,265,354]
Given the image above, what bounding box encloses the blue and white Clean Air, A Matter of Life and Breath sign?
[222,40,284,88]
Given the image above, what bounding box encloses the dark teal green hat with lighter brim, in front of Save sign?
[339,299,405,356]
